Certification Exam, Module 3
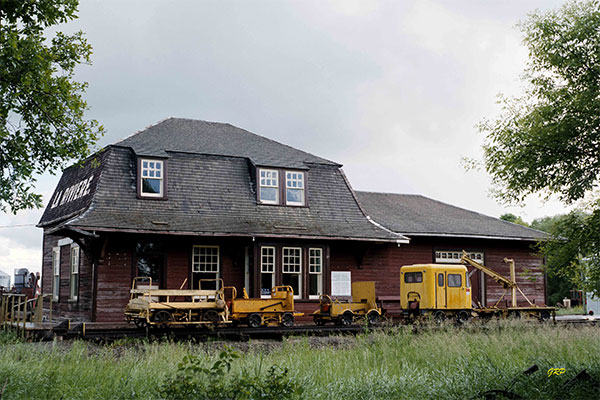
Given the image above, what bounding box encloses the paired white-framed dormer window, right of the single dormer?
[258,168,306,206]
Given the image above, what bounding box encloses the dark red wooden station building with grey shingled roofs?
[38,118,546,322]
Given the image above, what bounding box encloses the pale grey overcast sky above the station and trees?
[0,0,566,275]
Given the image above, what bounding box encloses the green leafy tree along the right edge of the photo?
[480,1,600,294]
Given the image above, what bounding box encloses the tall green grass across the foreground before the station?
[0,322,600,400]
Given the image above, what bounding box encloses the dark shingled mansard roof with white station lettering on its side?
[39,119,408,243]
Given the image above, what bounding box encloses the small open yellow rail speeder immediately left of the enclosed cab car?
[312,282,381,326]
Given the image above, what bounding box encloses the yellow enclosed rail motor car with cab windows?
[400,264,472,322]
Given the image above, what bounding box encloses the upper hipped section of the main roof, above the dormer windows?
[115,118,341,169]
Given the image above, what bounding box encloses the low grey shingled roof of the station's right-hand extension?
[356,191,546,240]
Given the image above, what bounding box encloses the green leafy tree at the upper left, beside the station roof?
[0,0,103,212]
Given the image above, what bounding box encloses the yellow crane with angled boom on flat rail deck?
[461,250,556,320]
